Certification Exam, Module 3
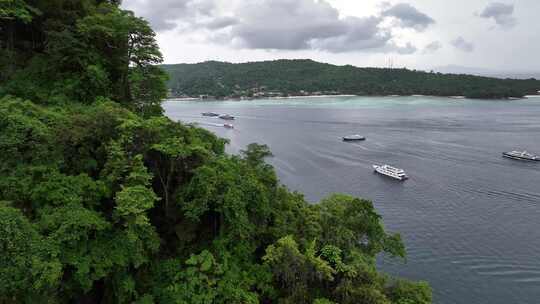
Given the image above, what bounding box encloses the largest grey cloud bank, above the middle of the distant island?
[220,0,426,54]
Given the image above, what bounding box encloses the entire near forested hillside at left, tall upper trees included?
[0,0,431,304]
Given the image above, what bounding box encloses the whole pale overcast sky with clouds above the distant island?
[123,0,540,71]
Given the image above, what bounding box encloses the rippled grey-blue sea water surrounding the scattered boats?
[165,97,540,304]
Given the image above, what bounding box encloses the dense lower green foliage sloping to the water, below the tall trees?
[0,98,431,303]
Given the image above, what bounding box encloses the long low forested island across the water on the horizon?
[161,60,540,99]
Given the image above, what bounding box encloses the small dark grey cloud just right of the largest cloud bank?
[382,3,435,31]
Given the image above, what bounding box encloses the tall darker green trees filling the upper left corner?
[0,0,167,115]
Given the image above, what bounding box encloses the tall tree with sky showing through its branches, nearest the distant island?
[77,4,166,115]
